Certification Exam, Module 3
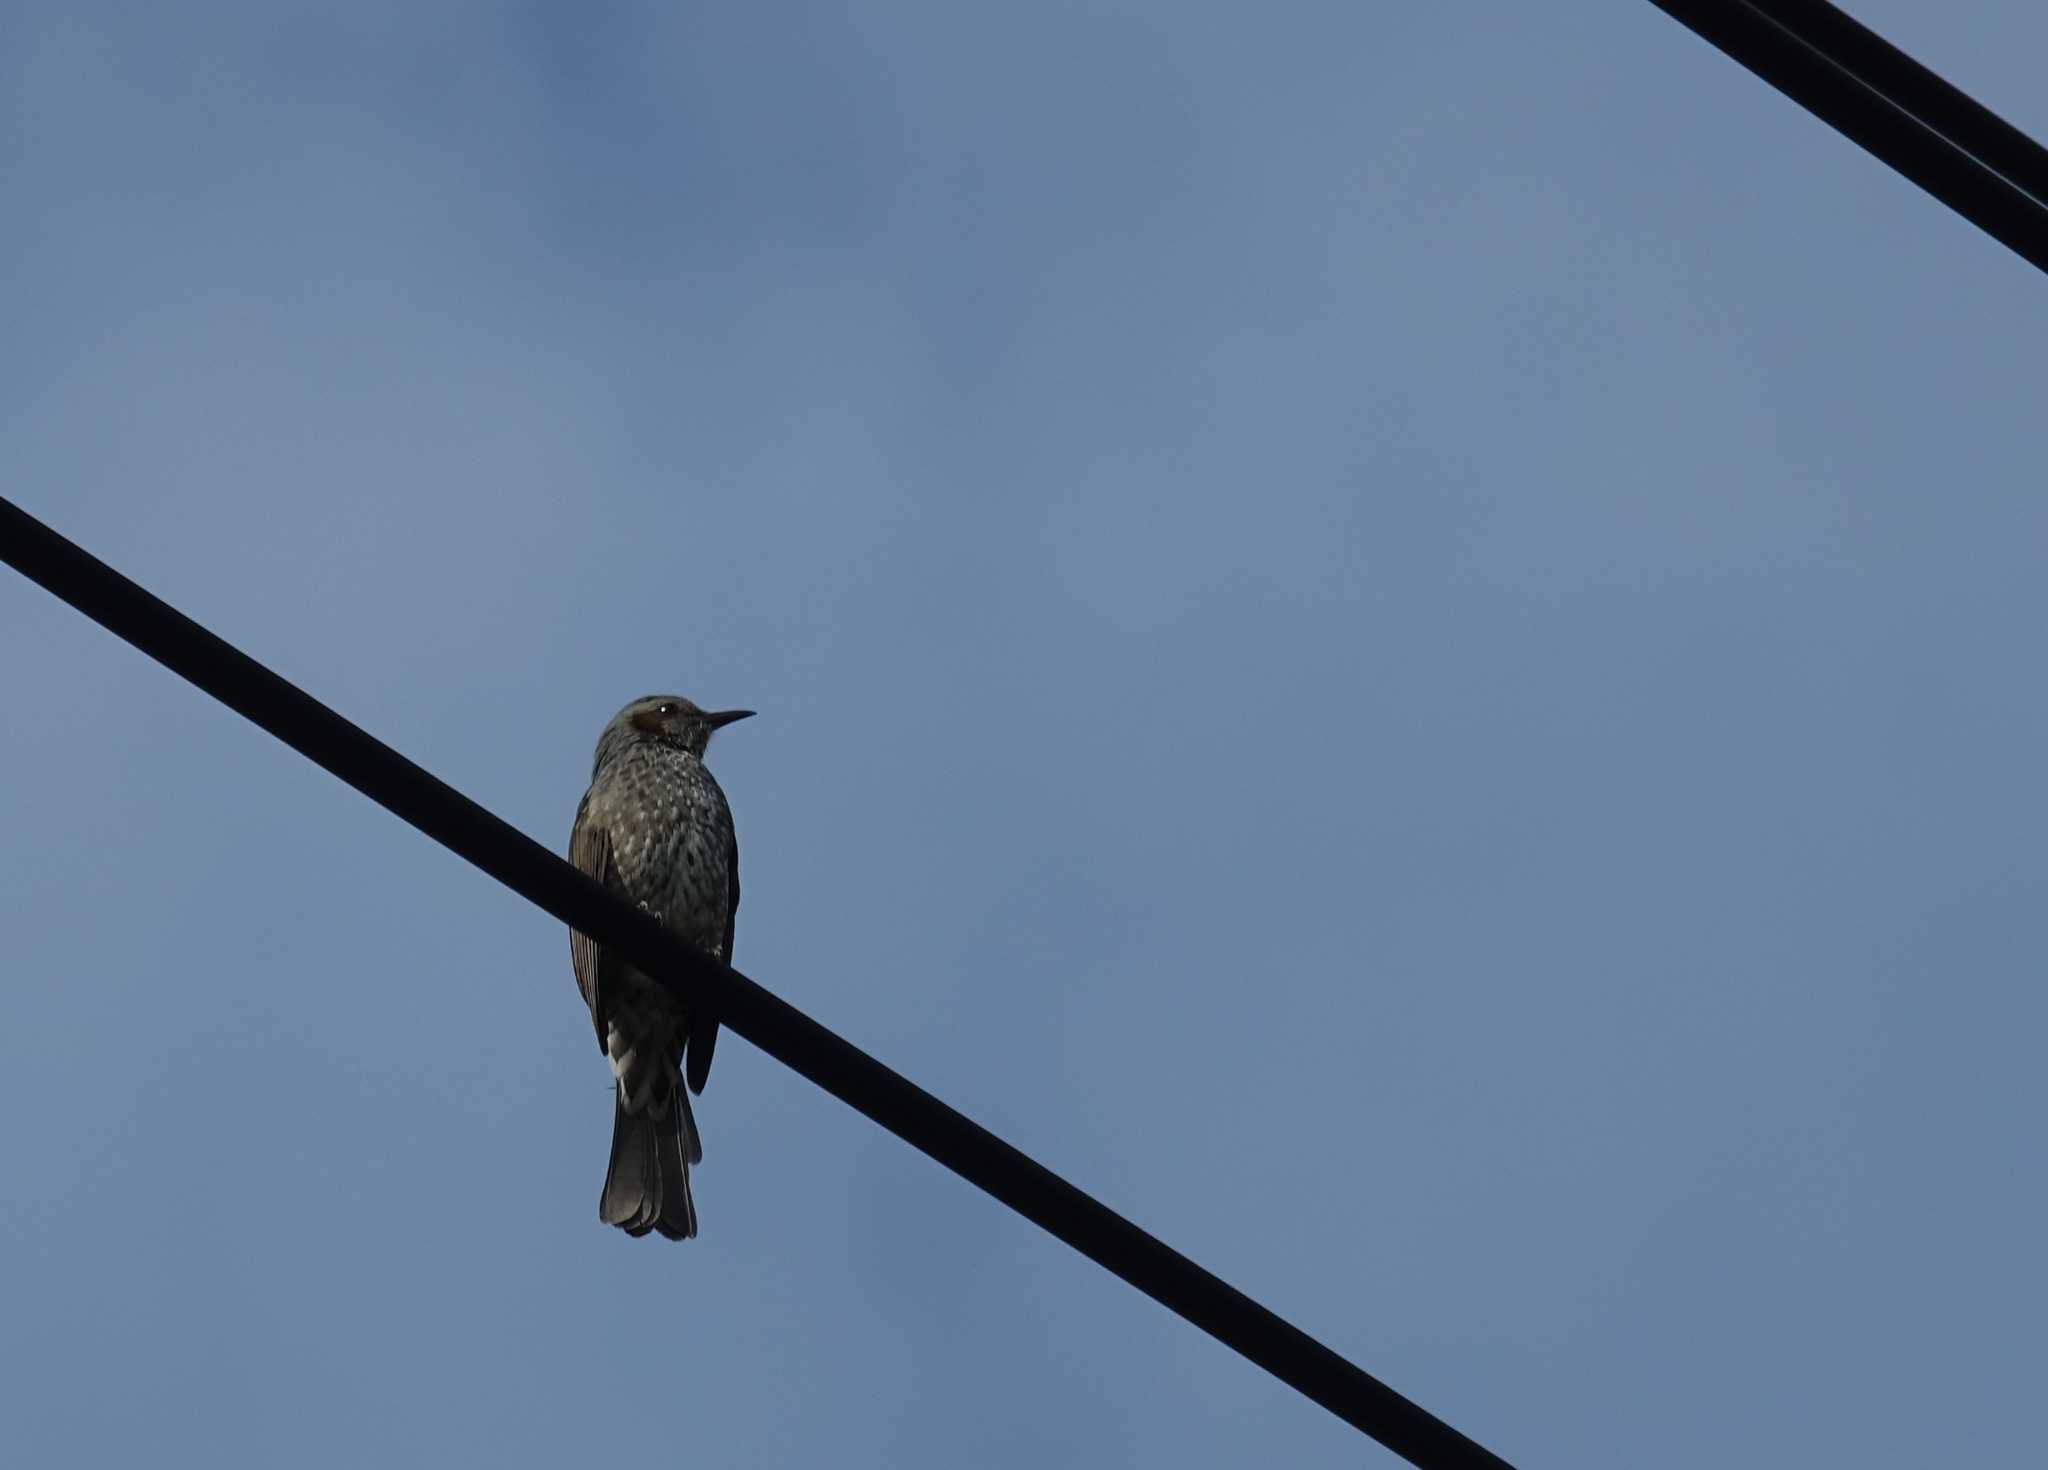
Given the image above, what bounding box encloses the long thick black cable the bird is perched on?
[0,500,1507,1470]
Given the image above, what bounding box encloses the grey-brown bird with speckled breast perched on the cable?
[569,694,754,1241]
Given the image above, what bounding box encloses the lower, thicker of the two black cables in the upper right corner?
[1651,0,2048,270]
